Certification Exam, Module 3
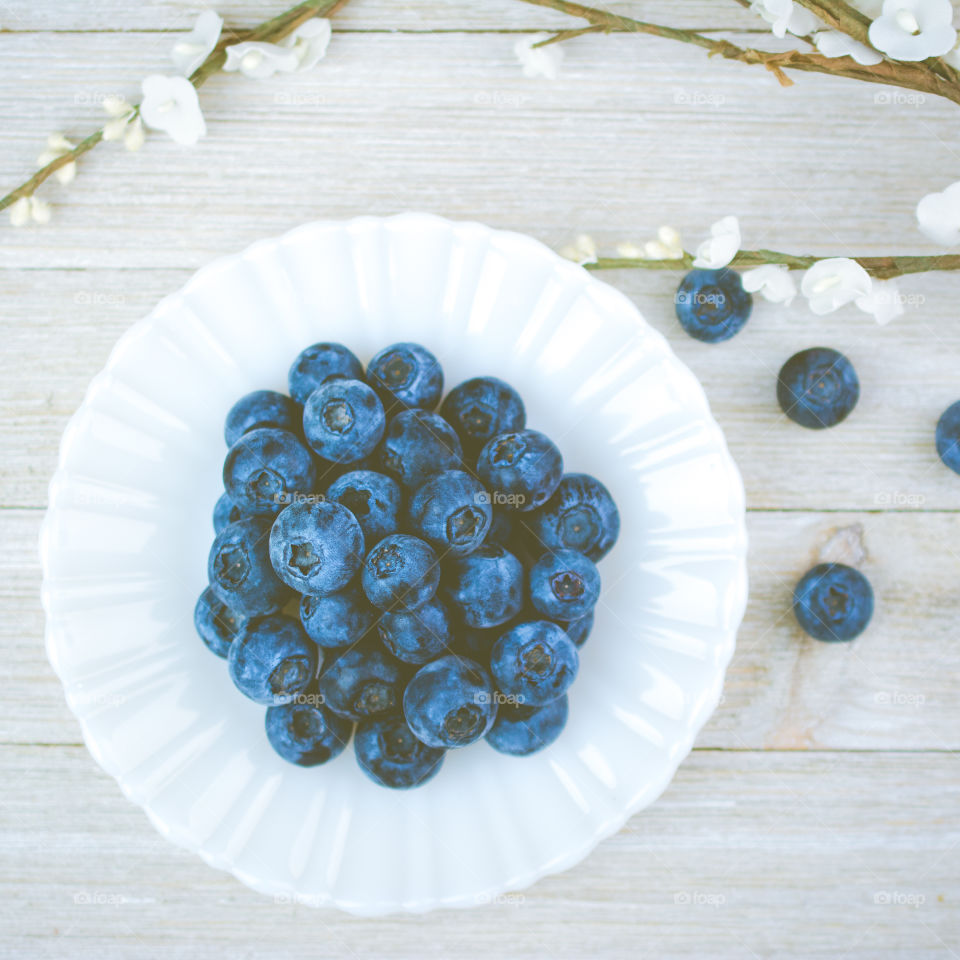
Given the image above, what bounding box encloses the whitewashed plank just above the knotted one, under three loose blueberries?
[0,262,960,511]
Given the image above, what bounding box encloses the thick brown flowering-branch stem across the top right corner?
[523,0,960,104]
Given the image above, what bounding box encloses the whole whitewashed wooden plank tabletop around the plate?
[0,0,960,960]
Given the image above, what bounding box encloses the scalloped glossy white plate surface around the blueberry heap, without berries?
[41,214,747,914]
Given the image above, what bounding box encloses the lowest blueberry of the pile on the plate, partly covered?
[353,716,444,789]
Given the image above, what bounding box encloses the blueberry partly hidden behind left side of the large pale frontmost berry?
[207,517,290,617]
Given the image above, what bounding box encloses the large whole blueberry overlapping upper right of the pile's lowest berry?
[403,654,497,747]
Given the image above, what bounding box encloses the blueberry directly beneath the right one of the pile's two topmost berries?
[380,410,463,490]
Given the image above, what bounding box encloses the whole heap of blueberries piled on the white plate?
[194,343,620,788]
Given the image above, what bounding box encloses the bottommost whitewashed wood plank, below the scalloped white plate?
[0,747,960,960]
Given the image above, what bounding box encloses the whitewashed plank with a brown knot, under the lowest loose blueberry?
[7,510,960,751]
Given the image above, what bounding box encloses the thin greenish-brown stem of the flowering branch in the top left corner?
[0,0,349,217]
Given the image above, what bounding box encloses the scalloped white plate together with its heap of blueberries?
[41,214,747,914]
